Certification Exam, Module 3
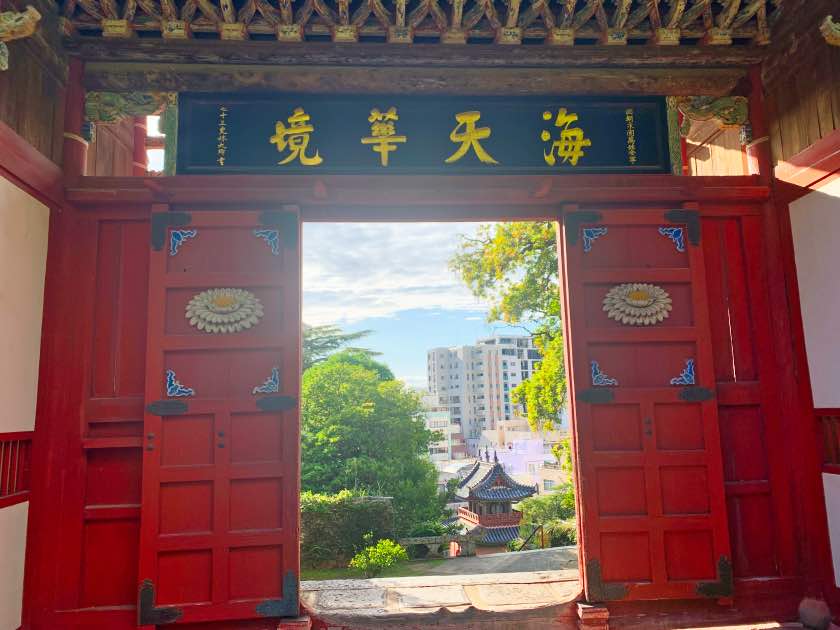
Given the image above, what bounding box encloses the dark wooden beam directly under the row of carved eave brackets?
[69,37,766,70]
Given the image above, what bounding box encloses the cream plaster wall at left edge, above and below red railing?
[0,177,49,630]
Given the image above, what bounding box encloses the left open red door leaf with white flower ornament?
[138,207,300,626]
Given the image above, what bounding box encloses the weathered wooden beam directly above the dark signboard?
[85,62,746,96]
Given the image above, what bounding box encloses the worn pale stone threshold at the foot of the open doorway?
[301,572,581,630]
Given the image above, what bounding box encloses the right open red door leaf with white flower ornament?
[558,210,732,601]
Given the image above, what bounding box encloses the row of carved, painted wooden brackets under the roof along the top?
[61,0,786,47]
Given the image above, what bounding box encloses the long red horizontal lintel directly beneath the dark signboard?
[67,175,769,221]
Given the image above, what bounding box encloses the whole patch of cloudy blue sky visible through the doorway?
[303,223,523,387]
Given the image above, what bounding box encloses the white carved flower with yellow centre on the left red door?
[186,288,263,333]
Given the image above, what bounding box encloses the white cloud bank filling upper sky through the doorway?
[303,223,487,325]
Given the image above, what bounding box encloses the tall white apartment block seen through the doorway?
[427,335,540,455]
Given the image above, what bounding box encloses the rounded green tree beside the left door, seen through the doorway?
[301,360,441,534]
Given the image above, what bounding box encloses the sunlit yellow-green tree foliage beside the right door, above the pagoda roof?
[450,221,566,431]
